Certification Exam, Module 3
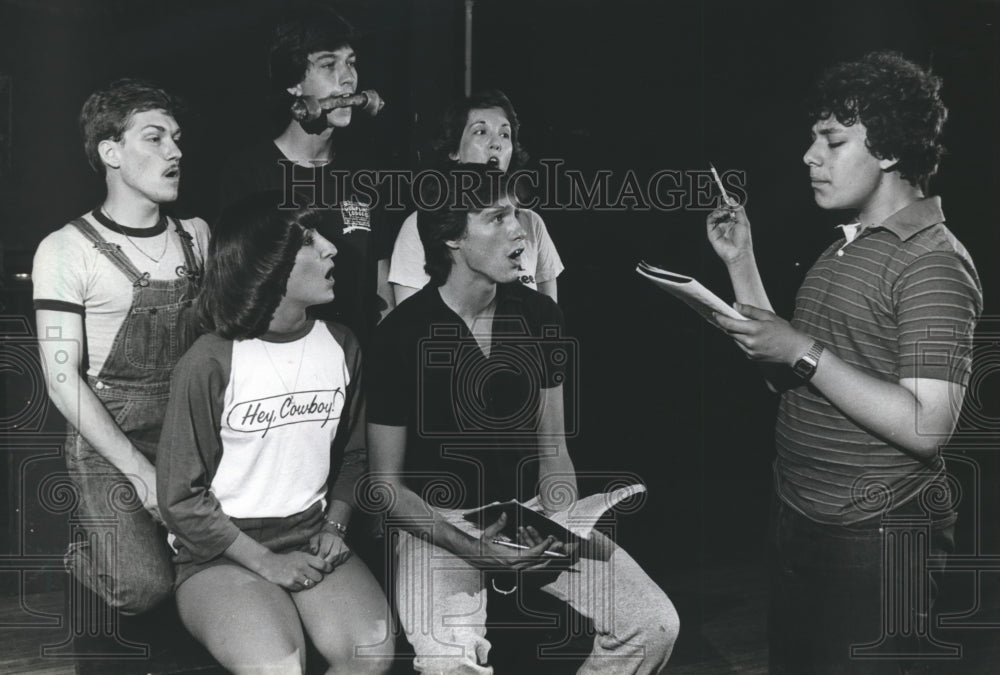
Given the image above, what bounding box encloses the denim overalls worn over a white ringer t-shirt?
[65,218,200,613]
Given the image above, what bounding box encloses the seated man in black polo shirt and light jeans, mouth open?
[368,165,678,673]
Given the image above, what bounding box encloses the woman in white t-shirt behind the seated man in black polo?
[389,90,563,305]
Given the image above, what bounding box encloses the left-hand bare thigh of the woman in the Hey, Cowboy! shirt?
[177,565,305,675]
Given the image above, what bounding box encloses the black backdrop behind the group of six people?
[0,0,1000,632]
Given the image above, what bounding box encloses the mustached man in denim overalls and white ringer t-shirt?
[32,80,208,614]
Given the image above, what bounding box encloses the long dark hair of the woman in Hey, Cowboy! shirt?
[198,191,323,340]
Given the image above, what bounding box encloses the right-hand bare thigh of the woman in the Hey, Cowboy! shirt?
[291,556,395,673]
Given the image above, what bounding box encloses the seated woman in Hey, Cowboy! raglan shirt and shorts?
[156,193,393,673]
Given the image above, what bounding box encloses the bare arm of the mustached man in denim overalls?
[35,309,160,520]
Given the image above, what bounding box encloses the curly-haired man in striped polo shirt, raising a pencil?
[708,52,982,673]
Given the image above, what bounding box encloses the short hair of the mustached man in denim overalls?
[80,78,185,176]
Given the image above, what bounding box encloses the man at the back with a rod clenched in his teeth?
[221,4,392,344]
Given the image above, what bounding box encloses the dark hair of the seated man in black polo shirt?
[417,162,514,286]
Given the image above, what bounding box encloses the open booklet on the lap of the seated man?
[463,483,646,544]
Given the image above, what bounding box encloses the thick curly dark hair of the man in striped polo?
[807,51,948,186]
